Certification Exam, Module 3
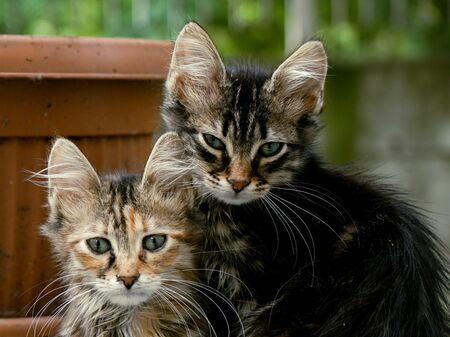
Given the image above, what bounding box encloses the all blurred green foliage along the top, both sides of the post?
[0,0,450,63]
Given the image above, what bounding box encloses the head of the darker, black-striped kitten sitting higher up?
[163,23,327,204]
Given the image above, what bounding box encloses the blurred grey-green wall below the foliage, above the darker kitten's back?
[323,62,450,247]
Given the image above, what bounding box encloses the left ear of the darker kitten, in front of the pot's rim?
[166,22,225,114]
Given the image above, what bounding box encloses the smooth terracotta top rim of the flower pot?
[0,35,172,81]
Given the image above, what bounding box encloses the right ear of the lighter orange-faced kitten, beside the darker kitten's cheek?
[141,132,195,207]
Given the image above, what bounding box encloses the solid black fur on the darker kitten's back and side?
[229,158,450,337]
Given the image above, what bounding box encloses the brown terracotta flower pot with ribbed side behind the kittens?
[0,36,171,337]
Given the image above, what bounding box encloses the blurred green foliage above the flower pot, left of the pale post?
[0,0,284,60]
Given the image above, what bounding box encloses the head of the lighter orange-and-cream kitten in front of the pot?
[43,133,199,307]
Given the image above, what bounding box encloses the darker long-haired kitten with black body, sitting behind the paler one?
[162,23,450,337]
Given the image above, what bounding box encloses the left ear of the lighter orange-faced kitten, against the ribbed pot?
[47,138,100,217]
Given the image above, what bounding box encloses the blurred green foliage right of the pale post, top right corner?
[317,0,450,63]
